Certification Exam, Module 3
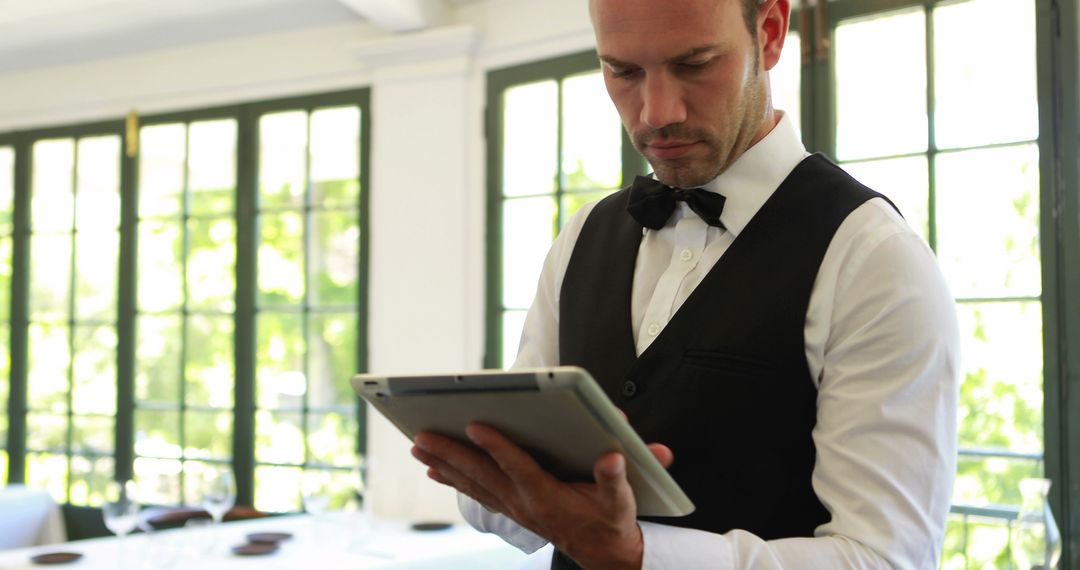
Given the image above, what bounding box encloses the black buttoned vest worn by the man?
[552,154,880,568]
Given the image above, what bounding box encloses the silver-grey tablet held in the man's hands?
[352,367,693,516]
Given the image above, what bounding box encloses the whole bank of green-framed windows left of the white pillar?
[0,91,368,511]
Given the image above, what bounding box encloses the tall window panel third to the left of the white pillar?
[26,134,120,504]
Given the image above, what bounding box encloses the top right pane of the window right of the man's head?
[934,0,1039,148]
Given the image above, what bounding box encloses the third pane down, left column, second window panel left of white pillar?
[135,315,184,402]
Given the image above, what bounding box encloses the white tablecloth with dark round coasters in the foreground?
[0,513,551,570]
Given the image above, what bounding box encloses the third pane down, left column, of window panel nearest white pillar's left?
[256,312,308,409]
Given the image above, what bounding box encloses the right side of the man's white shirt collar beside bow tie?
[703,113,808,238]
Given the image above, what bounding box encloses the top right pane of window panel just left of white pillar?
[311,107,360,208]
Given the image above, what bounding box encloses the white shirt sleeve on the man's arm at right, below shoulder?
[640,201,959,569]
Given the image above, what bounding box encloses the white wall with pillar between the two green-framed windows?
[0,0,592,519]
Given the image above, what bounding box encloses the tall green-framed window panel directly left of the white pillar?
[255,106,361,511]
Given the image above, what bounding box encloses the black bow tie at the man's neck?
[626,176,725,230]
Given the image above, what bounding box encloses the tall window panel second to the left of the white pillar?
[134,118,238,504]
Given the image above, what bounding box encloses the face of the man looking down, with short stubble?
[591,0,772,188]
